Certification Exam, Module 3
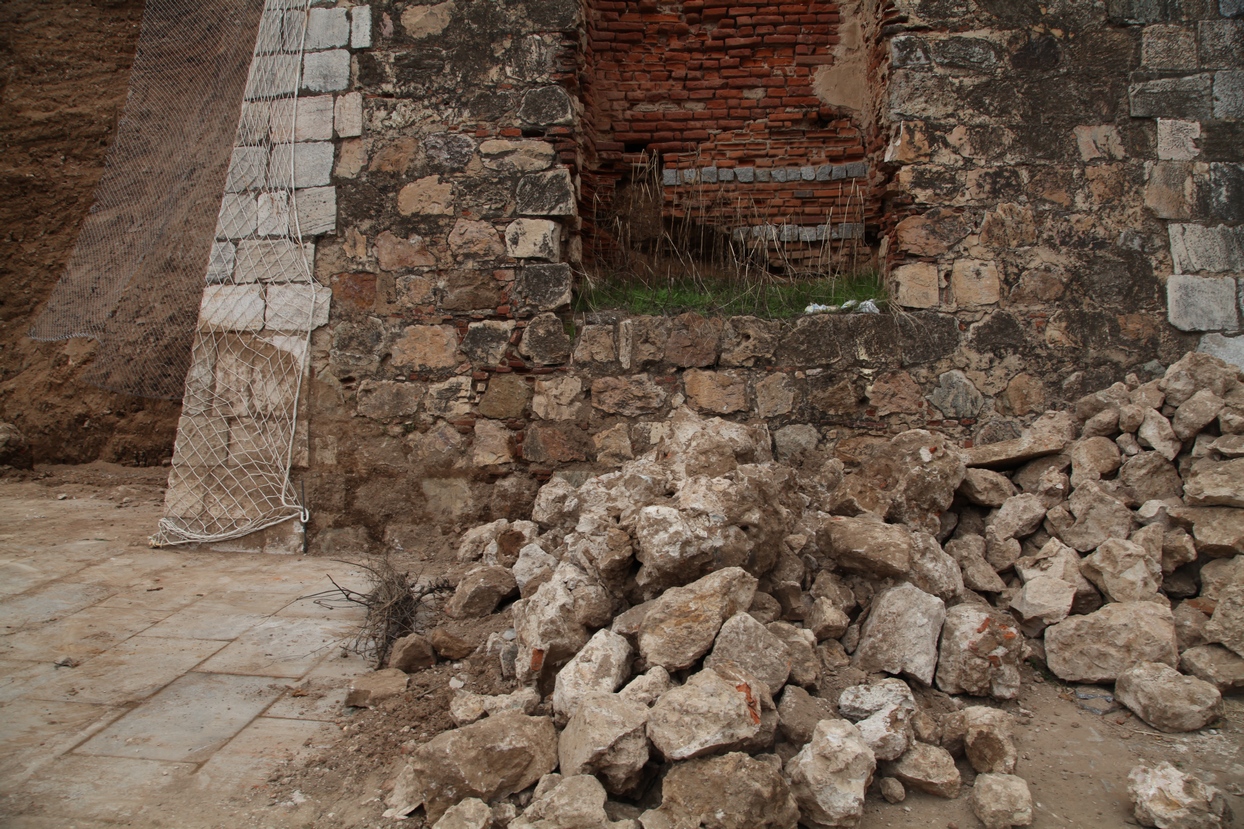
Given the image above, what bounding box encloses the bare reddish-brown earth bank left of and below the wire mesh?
[0,0,180,466]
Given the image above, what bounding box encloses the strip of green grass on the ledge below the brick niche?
[575,271,886,320]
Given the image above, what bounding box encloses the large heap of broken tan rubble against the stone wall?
[363,354,1244,829]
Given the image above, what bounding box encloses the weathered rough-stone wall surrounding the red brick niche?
[160,0,1244,553]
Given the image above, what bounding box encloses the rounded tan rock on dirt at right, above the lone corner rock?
[1115,662,1223,733]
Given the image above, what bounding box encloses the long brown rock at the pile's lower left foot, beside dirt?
[387,712,557,822]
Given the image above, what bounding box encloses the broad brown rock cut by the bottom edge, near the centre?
[639,752,799,829]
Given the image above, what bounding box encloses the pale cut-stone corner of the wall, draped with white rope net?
[152,0,325,545]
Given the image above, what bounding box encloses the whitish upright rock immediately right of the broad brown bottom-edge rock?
[786,719,875,829]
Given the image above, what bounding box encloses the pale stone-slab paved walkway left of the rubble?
[0,475,367,828]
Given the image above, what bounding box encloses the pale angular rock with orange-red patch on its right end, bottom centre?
[648,668,773,761]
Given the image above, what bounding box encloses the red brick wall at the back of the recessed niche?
[581,0,877,265]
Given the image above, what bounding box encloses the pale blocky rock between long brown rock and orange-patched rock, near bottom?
[557,693,648,794]
